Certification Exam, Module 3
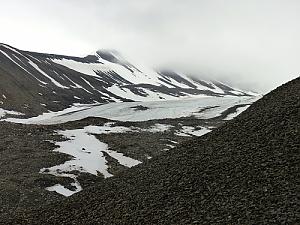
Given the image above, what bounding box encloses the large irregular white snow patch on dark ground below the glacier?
[40,124,141,196]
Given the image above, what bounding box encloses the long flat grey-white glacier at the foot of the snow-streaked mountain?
[3,97,257,124]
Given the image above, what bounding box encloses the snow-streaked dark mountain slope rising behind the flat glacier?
[0,44,251,115]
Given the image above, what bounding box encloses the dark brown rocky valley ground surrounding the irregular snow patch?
[0,113,231,219]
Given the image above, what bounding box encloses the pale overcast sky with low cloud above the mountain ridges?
[0,0,300,92]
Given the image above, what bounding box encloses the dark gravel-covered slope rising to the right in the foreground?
[2,78,300,224]
